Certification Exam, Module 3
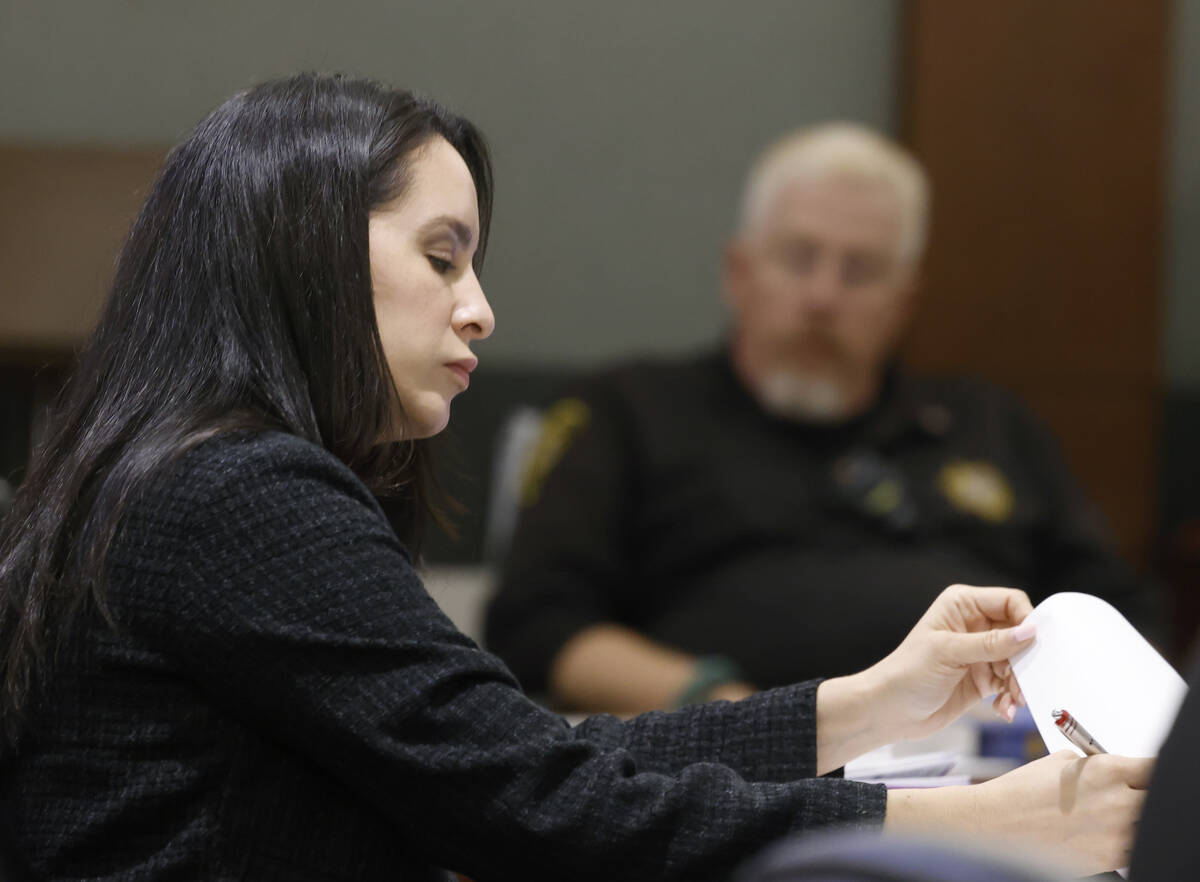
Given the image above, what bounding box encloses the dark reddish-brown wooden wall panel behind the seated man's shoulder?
[901,0,1169,560]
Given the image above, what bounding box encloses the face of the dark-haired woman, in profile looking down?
[370,138,496,440]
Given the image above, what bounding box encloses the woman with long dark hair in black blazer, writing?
[0,74,1146,882]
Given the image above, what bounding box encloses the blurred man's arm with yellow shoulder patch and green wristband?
[486,378,754,715]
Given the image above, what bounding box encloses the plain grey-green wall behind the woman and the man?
[0,0,900,366]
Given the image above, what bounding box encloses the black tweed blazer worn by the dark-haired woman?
[0,433,886,882]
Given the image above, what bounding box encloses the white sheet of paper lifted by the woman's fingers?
[1013,592,1187,756]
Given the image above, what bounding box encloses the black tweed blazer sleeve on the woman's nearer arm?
[133,439,886,880]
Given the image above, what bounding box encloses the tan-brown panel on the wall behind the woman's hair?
[0,146,166,350]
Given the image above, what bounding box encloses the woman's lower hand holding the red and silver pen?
[884,750,1153,875]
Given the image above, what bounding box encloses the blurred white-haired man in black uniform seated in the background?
[486,124,1154,713]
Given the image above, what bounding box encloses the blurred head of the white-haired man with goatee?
[726,125,929,422]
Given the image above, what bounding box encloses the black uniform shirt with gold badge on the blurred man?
[487,352,1151,690]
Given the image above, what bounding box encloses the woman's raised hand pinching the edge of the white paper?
[817,584,1033,774]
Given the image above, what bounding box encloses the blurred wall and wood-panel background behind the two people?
[0,0,1200,657]
